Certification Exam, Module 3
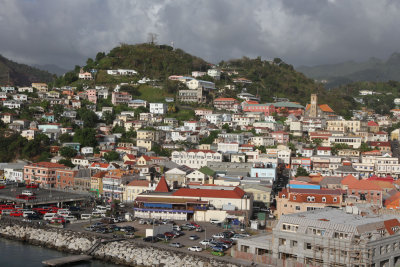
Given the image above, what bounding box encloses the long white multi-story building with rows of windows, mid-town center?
[171,149,222,169]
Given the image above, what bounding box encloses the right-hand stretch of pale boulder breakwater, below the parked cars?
[93,241,240,267]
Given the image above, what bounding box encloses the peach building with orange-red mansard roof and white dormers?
[276,188,343,218]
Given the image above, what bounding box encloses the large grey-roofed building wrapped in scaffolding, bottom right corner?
[235,208,400,267]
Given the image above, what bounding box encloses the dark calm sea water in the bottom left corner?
[0,238,121,267]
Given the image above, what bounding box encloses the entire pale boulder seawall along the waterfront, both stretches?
[0,220,240,267]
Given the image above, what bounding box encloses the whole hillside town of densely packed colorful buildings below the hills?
[0,66,400,266]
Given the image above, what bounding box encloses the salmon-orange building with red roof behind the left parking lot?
[24,162,68,187]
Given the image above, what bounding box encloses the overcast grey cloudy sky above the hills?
[0,0,400,68]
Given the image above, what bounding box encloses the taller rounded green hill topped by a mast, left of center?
[85,44,209,80]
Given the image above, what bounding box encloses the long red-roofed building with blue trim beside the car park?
[134,184,253,221]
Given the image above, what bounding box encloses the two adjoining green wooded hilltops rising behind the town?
[75,44,355,114]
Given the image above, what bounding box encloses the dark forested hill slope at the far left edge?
[0,55,53,86]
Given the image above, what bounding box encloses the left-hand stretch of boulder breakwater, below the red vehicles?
[0,224,96,254]
